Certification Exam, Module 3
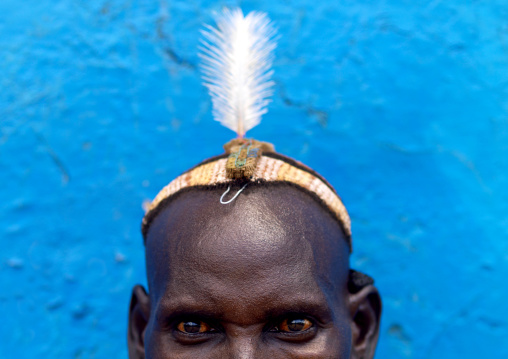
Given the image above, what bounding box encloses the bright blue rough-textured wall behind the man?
[0,0,508,359]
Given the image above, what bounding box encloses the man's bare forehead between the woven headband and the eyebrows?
[146,185,349,312]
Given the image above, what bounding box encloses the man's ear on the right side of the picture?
[349,285,381,359]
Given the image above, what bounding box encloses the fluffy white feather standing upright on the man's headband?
[199,9,276,138]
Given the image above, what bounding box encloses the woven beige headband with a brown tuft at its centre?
[142,140,351,252]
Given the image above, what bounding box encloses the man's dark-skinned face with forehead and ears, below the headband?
[128,184,381,359]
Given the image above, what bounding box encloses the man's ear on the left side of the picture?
[127,285,150,359]
